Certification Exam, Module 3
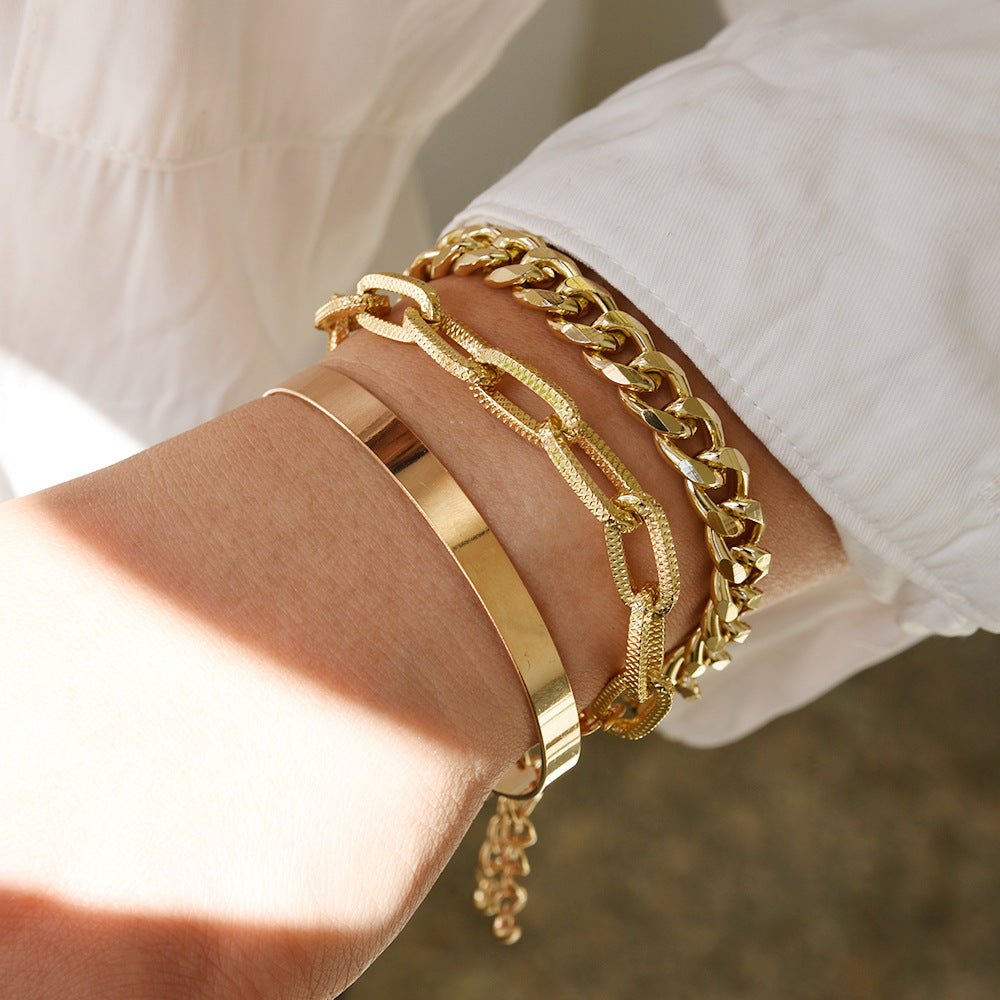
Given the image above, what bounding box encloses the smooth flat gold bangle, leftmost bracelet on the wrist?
[264,365,580,799]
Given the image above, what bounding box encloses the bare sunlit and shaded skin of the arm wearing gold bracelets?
[0,276,845,1000]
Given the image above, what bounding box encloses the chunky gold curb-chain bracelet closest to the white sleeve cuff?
[407,226,771,720]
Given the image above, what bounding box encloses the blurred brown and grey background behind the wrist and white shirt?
[350,0,1000,1000]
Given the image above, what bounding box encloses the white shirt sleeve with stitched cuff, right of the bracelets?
[455,0,1000,744]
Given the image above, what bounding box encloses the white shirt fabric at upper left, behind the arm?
[0,0,541,500]
